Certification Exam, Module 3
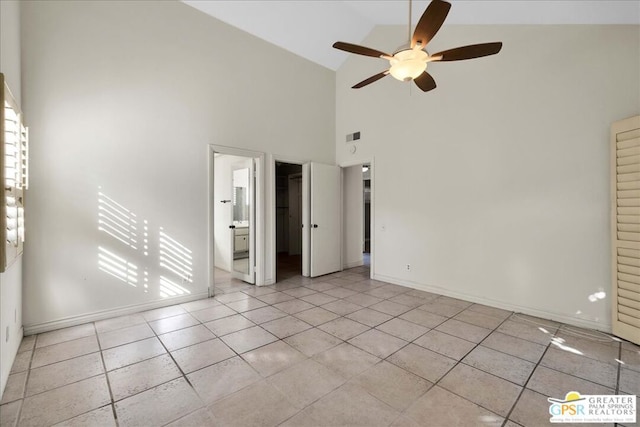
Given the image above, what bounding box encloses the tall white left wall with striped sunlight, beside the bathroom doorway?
[22,1,335,332]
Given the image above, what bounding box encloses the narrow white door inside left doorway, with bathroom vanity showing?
[229,163,255,283]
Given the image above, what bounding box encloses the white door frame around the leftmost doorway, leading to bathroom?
[207,144,266,297]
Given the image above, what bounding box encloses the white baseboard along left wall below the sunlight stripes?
[24,292,209,336]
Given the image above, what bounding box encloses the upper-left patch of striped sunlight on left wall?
[98,192,138,249]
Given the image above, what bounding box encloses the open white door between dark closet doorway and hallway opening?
[302,163,342,277]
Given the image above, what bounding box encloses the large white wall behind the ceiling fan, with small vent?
[336,25,640,330]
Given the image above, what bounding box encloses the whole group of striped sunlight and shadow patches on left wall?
[98,187,193,298]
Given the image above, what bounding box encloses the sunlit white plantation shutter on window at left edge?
[0,74,29,271]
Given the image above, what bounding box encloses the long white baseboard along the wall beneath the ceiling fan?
[373,274,611,334]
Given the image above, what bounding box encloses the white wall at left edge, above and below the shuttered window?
[0,0,22,398]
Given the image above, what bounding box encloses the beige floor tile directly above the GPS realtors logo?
[540,348,618,388]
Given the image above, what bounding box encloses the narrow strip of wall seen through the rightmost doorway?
[342,164,364,268]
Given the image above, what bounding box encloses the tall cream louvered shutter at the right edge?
[611,116,640,344]
